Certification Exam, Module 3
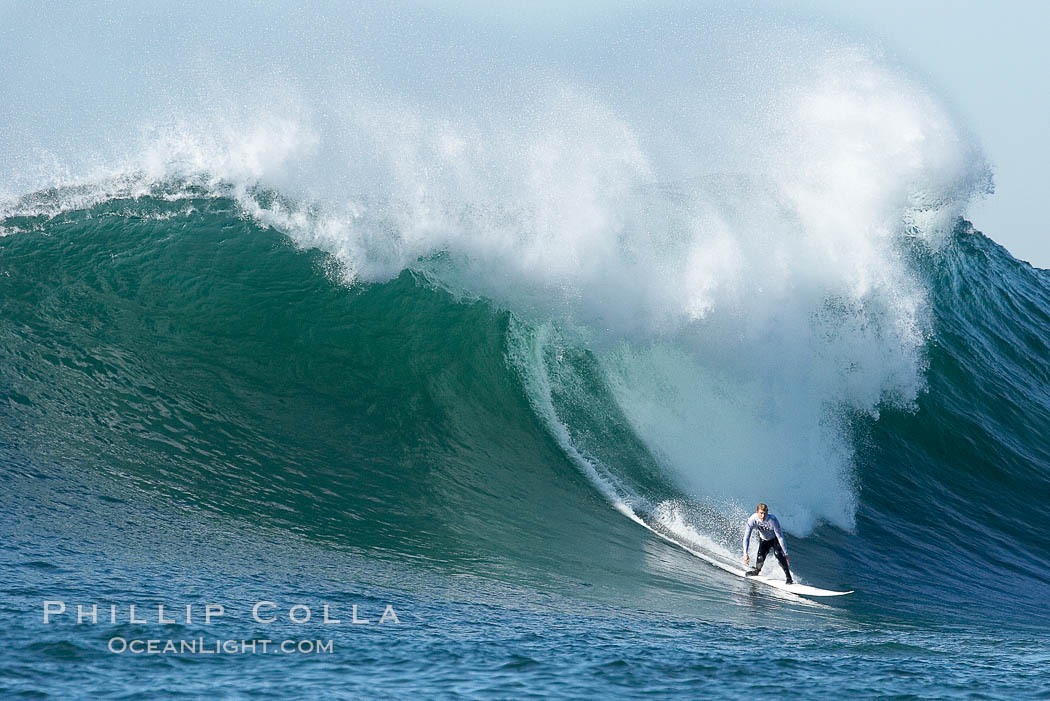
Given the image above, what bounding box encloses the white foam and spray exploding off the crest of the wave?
[0,0,988,533]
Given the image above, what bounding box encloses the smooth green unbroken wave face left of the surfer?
[0,197,672,596]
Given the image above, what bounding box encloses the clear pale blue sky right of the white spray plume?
[778,0,1050,268]
